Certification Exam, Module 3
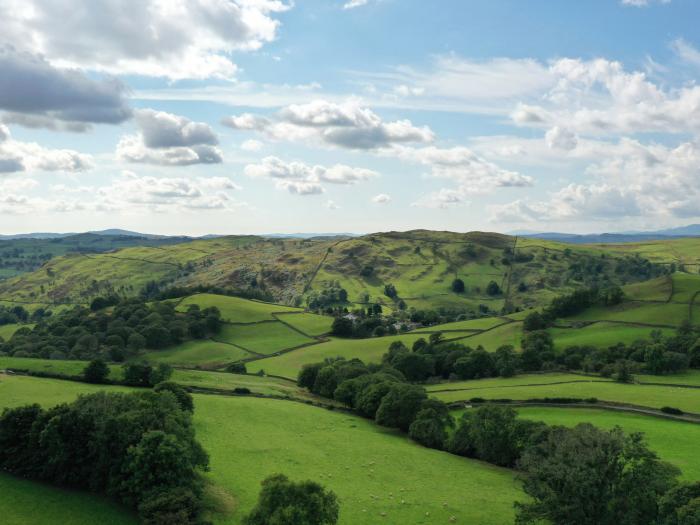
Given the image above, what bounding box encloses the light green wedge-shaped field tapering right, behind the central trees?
[247,334,424,379]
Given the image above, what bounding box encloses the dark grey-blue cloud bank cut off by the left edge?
[0,46,131,131]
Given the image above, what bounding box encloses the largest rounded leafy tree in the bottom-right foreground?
[516,423,678,525]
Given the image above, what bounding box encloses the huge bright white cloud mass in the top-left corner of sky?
[0,0,290,79]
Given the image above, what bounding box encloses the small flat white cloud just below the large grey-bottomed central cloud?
[244,157,378,195]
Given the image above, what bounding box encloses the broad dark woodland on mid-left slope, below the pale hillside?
[0,298,221,362]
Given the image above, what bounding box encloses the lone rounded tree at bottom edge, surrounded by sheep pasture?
[244,474,340,525]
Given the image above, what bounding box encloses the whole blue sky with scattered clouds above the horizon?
[0,0,700,235]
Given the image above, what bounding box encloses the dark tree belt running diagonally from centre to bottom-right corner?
[298,358,700,525]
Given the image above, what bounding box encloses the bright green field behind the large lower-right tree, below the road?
[518,407,700,481]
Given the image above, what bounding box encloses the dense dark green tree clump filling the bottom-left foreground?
[0,383,209,525]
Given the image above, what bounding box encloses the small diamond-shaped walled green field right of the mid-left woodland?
[215,321,314,355]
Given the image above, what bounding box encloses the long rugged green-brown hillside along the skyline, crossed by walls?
[0,230,688,313]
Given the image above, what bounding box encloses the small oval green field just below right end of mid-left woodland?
[146,339,251,368]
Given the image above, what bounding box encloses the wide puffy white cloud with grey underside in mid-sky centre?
[222,100,435,150]
